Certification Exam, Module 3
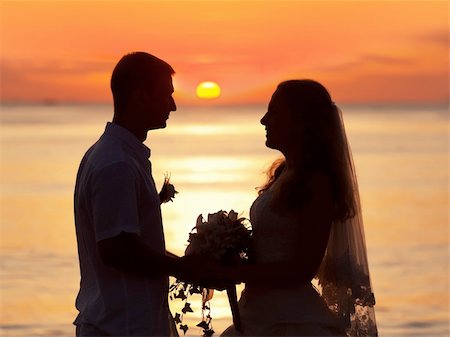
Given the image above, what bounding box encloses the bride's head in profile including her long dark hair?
[261,80,354,218]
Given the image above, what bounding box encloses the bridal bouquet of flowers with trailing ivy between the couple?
[170,210,252,336]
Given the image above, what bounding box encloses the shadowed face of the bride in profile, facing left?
[261,91,299,153]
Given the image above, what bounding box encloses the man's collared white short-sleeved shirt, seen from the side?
[74,123,170,336]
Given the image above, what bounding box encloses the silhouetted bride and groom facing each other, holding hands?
[74,52,376,336]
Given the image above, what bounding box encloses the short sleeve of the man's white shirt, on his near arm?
[91,162,140,242]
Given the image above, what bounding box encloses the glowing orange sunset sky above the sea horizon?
[0,0,449,104]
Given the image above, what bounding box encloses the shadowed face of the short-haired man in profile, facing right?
[139,75,177,130]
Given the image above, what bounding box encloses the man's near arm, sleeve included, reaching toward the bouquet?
[92,162,208,281]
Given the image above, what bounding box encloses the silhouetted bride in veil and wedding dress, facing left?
[218,80,377,336]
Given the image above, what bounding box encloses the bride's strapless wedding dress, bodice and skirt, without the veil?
[222,189,346,336]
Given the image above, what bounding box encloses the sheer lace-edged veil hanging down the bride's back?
[316,104,378,336]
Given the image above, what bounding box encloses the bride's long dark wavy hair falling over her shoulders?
[259,80,355,220]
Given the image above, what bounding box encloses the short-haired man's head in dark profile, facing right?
[111,52,176,136]
